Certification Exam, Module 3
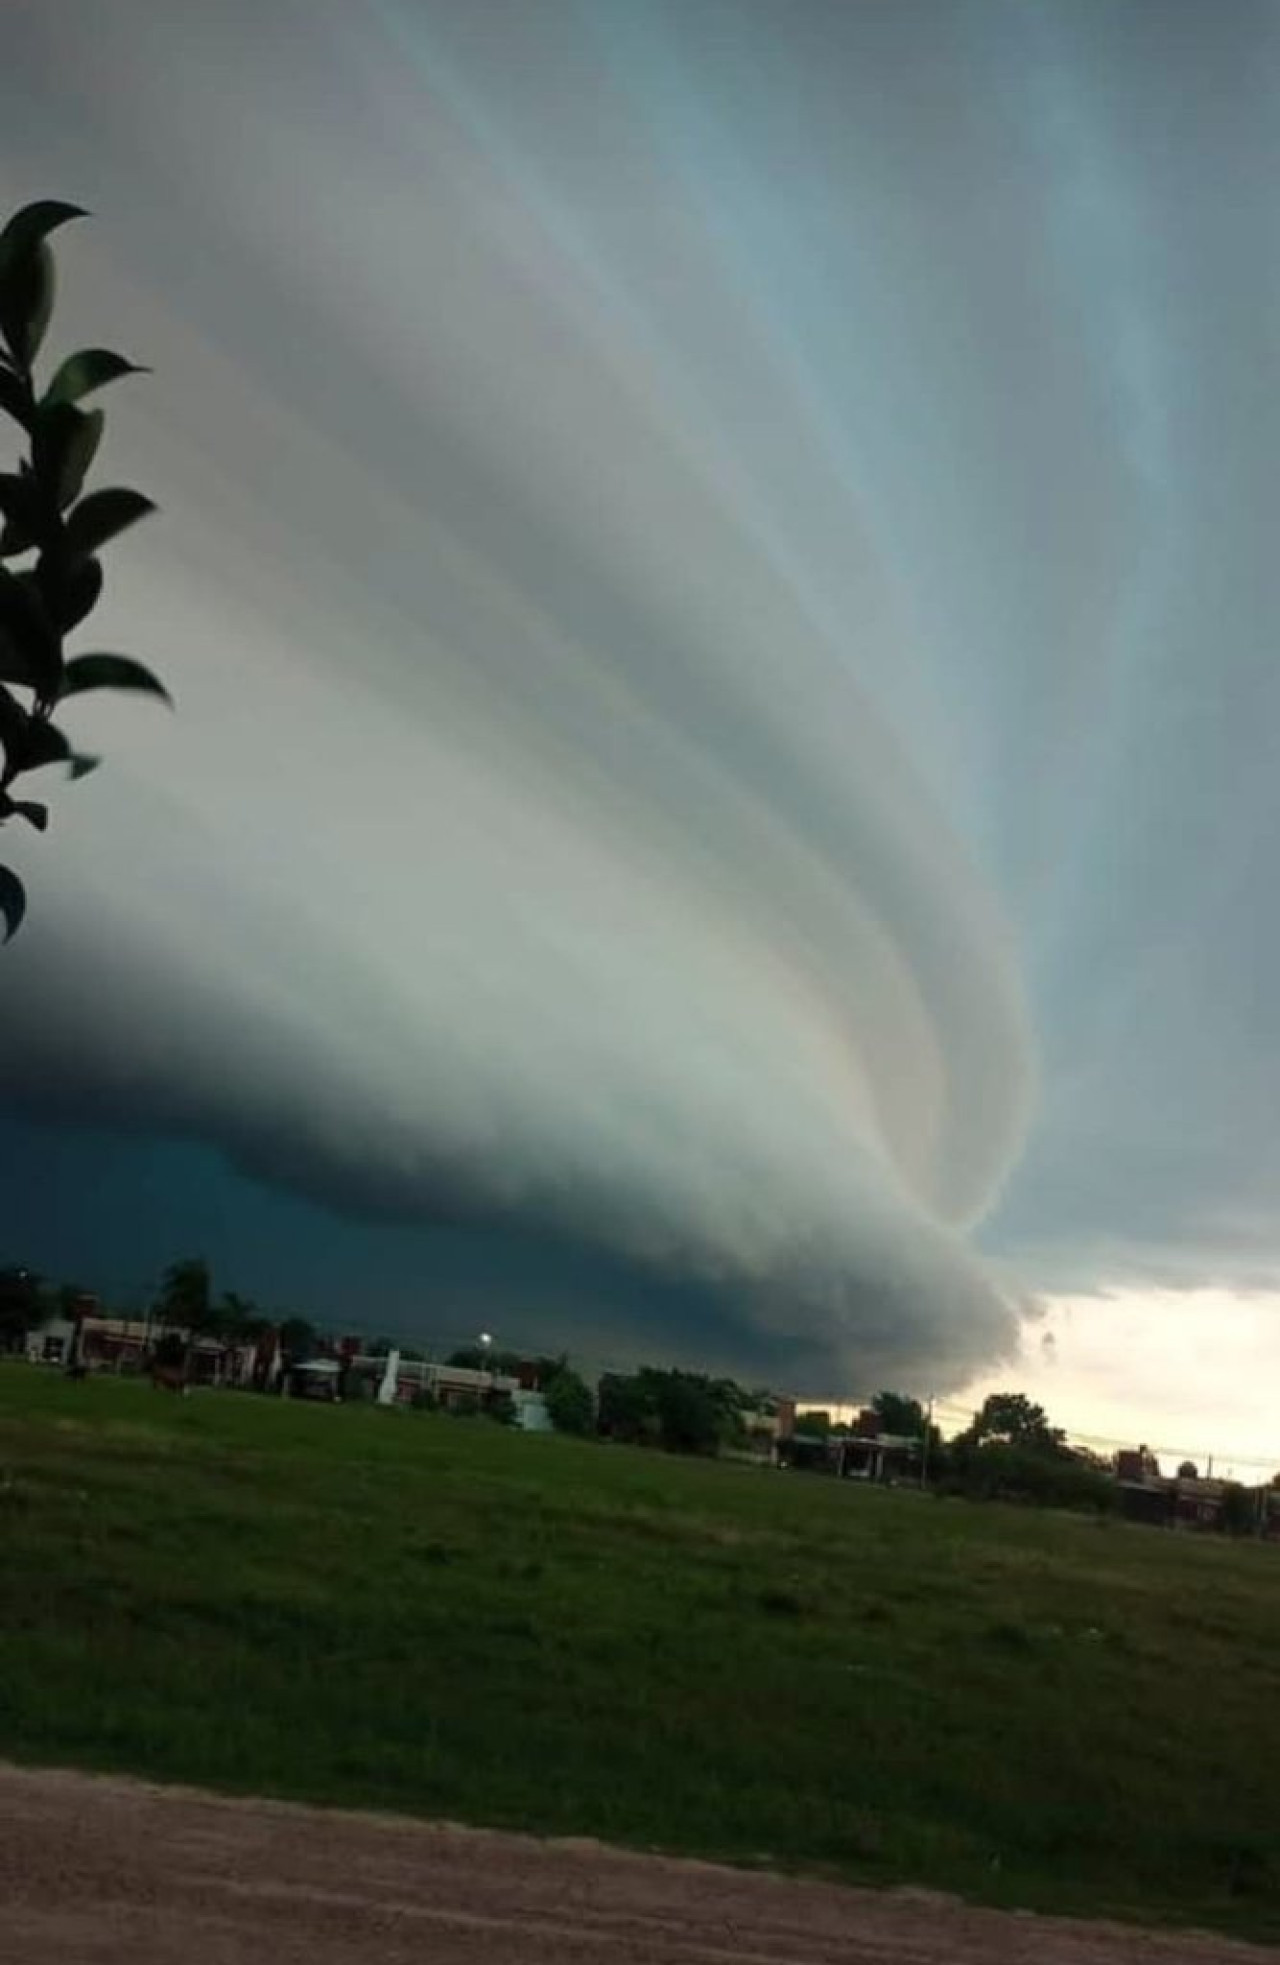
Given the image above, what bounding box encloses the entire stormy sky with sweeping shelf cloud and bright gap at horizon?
[0,0,1280,1464]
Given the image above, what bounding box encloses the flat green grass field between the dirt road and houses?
[0,1366,1280,1937]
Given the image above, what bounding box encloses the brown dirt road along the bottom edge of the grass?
[0,1767,1280,1965]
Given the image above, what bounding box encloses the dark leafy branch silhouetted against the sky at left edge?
[0,198,169,941]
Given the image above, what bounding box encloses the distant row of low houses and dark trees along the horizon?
[0,1258,1280,1543]
